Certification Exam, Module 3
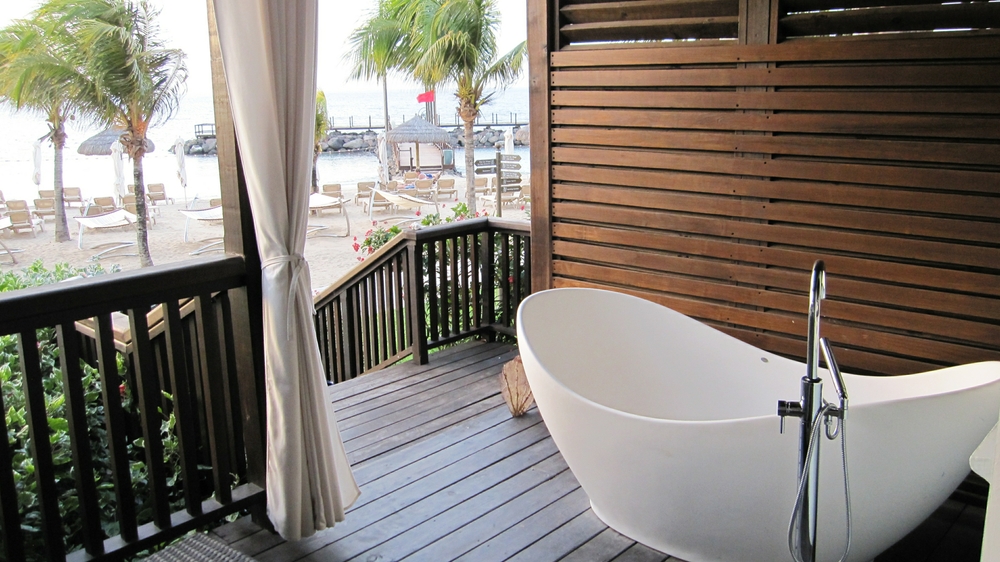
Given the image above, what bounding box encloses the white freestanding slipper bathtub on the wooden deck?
[517,289,1000,562]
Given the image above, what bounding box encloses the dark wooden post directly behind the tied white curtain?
[207,0,267,508]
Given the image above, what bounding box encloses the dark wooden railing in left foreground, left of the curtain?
[0,257,264,561]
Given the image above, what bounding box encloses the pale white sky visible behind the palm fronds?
[0,0,527,96]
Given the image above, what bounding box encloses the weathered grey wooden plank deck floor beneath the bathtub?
[207,344,983,562]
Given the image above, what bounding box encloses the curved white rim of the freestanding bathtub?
[516,287,1000,424]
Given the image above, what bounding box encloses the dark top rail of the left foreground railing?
[0,256,246,334]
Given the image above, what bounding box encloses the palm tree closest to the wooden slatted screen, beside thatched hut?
[412,0,525,213]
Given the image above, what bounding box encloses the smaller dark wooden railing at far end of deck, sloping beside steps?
[315,218,531,383]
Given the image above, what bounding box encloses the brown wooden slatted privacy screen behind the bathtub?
[529,0,1000,374]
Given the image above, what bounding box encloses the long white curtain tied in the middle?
[215,0,360,540]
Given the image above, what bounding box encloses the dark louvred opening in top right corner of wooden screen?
[778,2,1000,37]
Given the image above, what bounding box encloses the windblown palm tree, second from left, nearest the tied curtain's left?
[39,0,187,267]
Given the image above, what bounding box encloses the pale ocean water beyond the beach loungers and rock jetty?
[0,88,528,204]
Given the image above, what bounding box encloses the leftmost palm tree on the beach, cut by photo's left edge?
[0,12,89,242]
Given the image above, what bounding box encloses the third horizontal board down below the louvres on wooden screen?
[552,90,1000,114]
